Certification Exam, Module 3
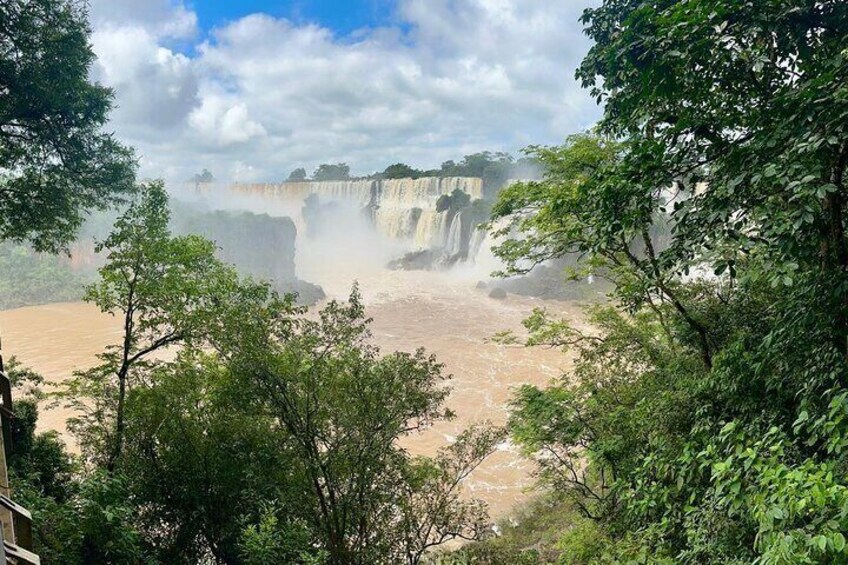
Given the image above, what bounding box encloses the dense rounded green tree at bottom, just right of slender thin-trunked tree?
[121,349,312,563]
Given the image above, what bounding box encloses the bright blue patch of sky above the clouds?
[188,0,395,35]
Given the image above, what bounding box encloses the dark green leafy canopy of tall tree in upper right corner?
[578,0,848,354]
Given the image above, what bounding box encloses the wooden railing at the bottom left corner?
[0,346,41,565]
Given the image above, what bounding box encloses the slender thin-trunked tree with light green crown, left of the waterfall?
[65,182,237,470]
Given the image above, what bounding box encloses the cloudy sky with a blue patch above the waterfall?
[90,0,600,182]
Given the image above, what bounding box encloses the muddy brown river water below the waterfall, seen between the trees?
[0,271,582,518]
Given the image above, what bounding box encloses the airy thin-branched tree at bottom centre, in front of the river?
[219,290,502,565]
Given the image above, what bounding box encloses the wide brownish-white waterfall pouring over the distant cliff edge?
[231,177,483,260]
